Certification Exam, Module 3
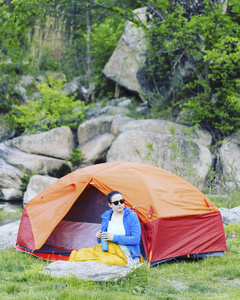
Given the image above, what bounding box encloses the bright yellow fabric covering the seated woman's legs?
[69,242,127,266]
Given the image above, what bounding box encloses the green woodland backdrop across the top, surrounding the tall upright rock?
[0,0,240,144]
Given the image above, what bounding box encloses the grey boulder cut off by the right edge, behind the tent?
[219,132,240,187]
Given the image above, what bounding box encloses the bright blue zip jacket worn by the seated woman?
[101,207,141,258]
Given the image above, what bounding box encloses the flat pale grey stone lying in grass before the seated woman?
[41,261,140,281]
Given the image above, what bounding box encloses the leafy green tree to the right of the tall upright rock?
[141,0,240,140]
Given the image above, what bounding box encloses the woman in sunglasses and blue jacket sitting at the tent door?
[69,191,141,266]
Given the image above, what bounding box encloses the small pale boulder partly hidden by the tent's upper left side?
[23,175,58,204]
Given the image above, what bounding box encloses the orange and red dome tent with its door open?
[16,162,227,265]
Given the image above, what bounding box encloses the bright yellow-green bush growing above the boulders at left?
[6,76,85,133]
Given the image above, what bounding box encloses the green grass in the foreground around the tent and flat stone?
[0,223,240,300]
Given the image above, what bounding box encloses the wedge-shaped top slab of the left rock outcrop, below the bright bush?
[9,126,74,160]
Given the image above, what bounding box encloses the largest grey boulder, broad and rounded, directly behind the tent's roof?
[107,120,212,188]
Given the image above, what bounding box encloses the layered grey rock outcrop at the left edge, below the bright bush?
[0,127,73,201]
